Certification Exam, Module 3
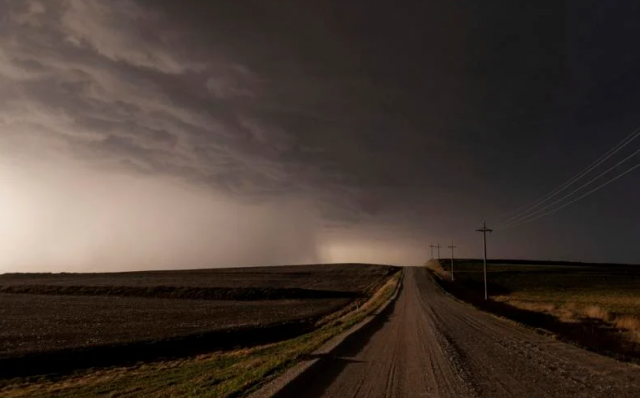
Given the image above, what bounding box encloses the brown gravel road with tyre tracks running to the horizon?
[278,268,640,398]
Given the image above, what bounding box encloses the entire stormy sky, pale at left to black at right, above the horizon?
[0,0,640,269]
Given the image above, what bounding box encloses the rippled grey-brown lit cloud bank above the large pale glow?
[0,0,384,224]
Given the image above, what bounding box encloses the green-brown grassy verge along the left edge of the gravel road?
[0,273,401,398]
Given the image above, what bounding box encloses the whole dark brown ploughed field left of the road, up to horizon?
[0,264,397,377]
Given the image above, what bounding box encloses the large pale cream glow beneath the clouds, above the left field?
[0,158,319,272]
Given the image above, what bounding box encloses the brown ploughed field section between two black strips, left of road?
[0,294,350,358]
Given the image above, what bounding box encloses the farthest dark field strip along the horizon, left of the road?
[0,264,389,301]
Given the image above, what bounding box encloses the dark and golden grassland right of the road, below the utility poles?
[428,262,640,363]
